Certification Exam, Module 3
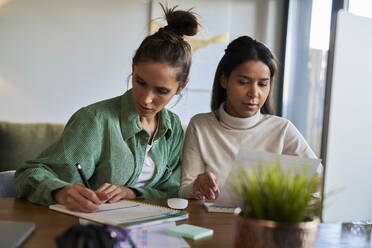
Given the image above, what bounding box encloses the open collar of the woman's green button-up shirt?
[120,89,172,140]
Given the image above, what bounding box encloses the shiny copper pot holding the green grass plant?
[235,216,319,248]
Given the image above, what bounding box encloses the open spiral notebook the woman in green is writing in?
[49,200,189,229]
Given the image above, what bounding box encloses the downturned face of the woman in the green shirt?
[132,61,186,119]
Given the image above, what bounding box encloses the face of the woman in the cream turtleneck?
[220,60,270,118]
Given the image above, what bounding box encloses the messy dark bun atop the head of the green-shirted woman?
[160,4,199,36]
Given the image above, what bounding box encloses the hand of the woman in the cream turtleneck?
[193,171,220,200]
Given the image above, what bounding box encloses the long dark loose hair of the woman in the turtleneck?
[211,36,277,114]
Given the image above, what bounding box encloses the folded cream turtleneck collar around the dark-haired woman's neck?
[217,103,262,129]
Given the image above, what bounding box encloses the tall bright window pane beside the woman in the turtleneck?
[282,0,332,156]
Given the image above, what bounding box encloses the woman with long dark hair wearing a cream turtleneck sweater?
[179,36,316,200]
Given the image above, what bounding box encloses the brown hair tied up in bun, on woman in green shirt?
[132,4,199,86]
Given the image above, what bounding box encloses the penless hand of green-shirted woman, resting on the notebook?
[96,183,136,203]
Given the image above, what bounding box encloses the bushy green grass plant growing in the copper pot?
[231,160,321,223]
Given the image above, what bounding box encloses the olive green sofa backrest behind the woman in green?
[0,121,64,171]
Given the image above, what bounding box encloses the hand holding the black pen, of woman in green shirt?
[53,183,108,213]
